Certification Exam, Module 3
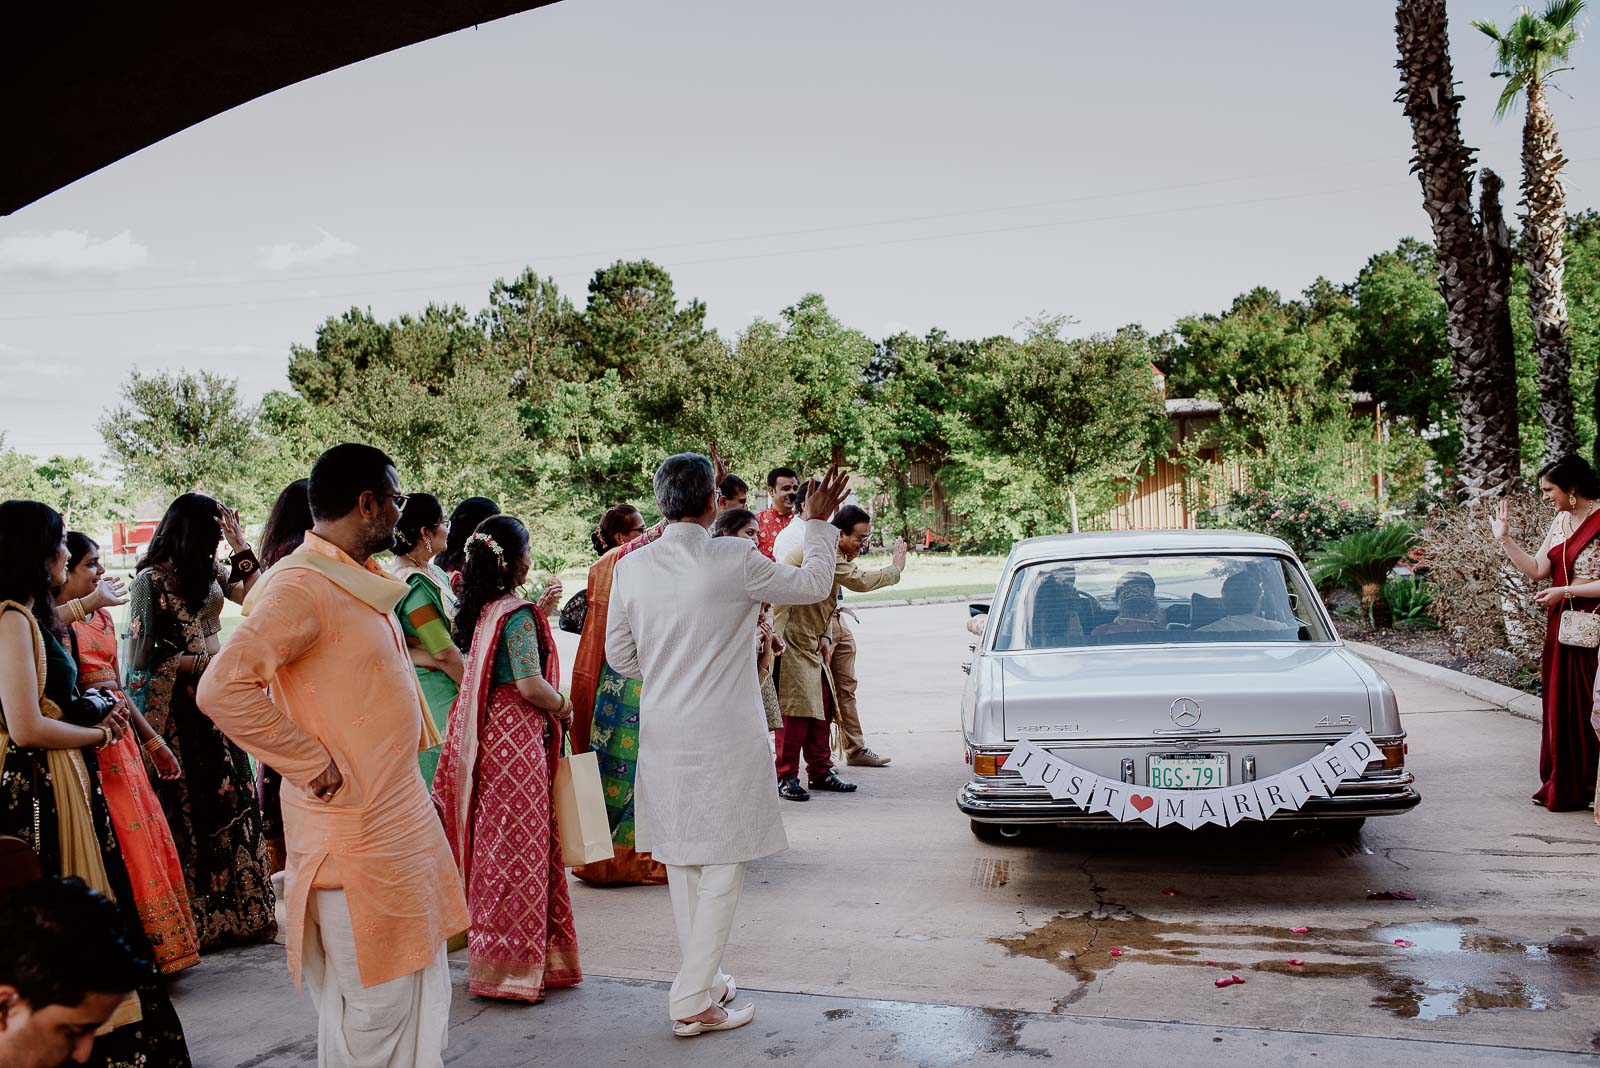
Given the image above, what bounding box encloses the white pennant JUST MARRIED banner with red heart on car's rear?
[1005,731,1378,828]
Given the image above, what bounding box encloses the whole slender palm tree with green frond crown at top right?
[1474,0,1584,459]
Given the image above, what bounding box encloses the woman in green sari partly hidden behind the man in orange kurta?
[392,492,462,787]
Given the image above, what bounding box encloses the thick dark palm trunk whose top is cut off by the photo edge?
[1395,0,1522,499]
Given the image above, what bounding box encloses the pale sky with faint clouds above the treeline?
[0,0,1600,454]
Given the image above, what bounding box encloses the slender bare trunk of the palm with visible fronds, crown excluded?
[1522,80,1578,462]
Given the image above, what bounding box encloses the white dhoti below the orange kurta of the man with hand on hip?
[301,889,450,1068]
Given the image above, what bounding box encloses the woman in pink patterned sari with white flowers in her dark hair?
[434,515,582,1001]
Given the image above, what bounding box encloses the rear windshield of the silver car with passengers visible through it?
[994,555,1333,652]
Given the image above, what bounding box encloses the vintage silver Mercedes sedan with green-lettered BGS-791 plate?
[957,531,1421,839]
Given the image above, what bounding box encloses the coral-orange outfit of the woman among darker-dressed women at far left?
[72,609,200,975]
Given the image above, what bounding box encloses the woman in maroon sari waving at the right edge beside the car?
[1490,456,1600,812]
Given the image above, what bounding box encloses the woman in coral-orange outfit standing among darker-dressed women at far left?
[56,531,200,975]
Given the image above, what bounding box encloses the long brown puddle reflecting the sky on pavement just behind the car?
[992,913,1600,1020]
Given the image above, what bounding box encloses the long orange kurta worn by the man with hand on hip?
[198,534,467,986]
